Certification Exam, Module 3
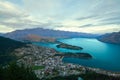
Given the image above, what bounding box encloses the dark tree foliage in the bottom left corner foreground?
[0,63,39,80]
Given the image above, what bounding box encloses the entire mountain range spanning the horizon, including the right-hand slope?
[0,28,120,44]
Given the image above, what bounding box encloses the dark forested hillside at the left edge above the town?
[0,36,25,64]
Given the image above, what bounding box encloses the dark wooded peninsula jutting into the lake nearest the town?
[54,52,92,59]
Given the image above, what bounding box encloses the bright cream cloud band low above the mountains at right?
[55,25,120,34]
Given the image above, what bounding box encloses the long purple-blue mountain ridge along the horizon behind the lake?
[4,28,98,40]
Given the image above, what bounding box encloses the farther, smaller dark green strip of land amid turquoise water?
[56,43,83,50]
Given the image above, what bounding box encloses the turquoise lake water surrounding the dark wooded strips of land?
[33,38,120,72]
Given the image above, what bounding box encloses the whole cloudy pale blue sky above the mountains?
[0,0,120,34]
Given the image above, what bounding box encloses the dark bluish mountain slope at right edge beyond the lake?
[98,32,120,44]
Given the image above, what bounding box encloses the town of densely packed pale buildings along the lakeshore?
[14,44,120,79]
